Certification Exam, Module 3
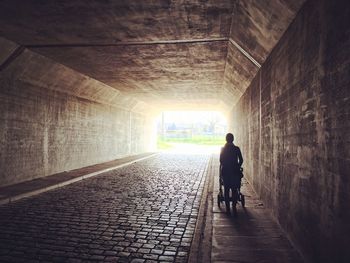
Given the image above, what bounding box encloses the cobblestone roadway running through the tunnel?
[0,154,209,262]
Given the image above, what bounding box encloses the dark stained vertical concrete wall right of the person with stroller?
[231,0,350,262]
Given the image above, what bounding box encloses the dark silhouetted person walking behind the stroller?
[220,133,243,214]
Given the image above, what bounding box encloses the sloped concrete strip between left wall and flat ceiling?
[0,37,152,112]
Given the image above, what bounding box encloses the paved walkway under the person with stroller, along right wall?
[210,157,304,263]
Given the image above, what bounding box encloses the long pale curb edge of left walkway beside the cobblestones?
[0,153,158,205]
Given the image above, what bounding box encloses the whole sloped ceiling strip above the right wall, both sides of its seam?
[222,0,305,105]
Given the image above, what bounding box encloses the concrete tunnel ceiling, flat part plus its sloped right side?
[0,0,304,112]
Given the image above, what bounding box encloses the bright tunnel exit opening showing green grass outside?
[157,111,228,154]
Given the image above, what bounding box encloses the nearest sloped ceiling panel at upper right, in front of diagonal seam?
[230,0,305,65]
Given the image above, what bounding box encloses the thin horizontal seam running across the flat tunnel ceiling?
[26,37,229,48]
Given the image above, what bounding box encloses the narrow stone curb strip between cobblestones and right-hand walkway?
[188,155,214,263]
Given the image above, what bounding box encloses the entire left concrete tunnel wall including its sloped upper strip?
[0,39,153,189]
